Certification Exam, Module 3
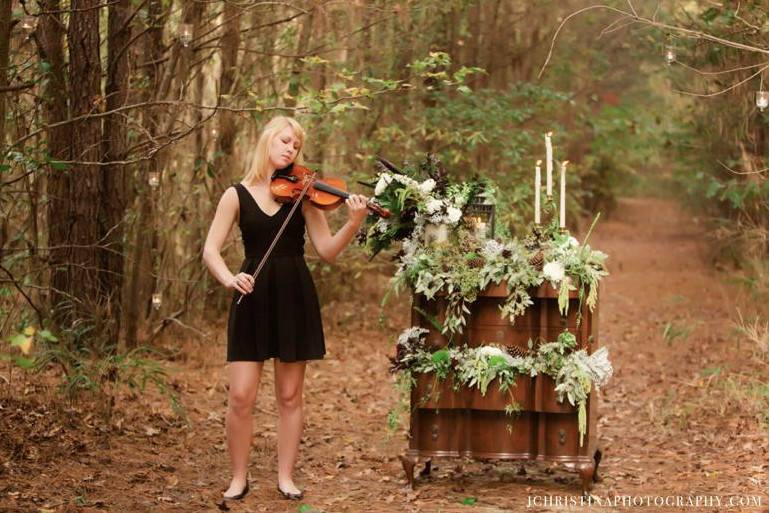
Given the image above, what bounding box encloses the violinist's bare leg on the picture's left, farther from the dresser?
[225,362,263,496]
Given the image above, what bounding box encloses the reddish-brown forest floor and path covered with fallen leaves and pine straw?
[0,198,768,513]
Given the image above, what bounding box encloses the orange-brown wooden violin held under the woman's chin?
[270,164,390,217]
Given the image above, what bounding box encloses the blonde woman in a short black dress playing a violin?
[203,116,367,499]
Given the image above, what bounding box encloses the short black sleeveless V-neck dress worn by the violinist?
[227,183,326,362]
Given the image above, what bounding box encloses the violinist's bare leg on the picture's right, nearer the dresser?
[275,360,306,493]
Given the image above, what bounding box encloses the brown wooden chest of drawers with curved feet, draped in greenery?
[401,284,601,493]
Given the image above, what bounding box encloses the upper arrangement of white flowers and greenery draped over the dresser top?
[362,155,607,335]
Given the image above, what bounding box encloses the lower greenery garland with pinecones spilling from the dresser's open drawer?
[391,327,612,446]
